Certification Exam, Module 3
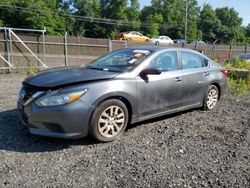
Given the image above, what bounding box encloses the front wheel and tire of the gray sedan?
[89,99,128,142]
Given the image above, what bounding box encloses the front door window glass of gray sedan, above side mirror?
[149,52,178,71]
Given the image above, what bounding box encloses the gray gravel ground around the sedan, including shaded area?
[0,75,250,187]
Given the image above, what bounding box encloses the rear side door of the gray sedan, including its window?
[180,51,210,106]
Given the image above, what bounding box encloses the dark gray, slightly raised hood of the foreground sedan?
[23,67,119,90]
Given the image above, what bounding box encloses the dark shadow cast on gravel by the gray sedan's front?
[0,109,97,152]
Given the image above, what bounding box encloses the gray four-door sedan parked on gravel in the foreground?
[17,46,227,142]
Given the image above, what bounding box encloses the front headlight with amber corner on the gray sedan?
[36,89,87,107]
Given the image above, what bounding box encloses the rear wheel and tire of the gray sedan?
[203,85,219,111]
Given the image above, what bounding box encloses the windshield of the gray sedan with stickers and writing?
[87,49,152,72]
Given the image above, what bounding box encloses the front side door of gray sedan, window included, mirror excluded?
[137,51,183,119]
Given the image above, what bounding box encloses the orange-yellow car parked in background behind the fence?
[116,31,150,41]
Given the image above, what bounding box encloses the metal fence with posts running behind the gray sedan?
[0,28,250,69]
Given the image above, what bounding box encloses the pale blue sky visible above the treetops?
[139,0,250,26]
